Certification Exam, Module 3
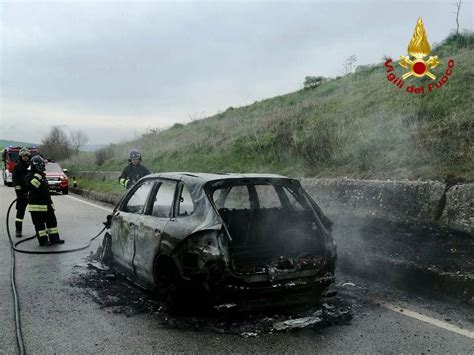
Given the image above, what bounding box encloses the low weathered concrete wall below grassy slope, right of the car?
[301,178,474,236]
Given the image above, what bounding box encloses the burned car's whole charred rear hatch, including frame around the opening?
[206,178,335,290]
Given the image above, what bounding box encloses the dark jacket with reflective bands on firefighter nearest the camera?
[25,169,54,212]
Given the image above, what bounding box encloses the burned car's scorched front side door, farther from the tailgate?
[111,180,156,273]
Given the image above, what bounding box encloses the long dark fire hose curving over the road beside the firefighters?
[6,199,107,355]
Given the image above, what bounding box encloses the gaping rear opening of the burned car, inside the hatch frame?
[211,184,325,273]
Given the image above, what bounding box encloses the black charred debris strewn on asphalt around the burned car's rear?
[71,260,353,338]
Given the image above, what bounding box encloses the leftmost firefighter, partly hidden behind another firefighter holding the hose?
[12,148,31,238]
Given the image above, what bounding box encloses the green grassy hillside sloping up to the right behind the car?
[68,34,474,181]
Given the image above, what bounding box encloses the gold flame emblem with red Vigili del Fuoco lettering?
[385,17,454,94]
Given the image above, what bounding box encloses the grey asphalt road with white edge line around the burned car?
[0,185,474,354]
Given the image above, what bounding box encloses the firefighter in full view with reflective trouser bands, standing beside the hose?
[25,155,64,246]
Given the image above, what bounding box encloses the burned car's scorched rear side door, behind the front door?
[133,179,177,283]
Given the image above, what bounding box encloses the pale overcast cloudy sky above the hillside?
[0,0,474,144]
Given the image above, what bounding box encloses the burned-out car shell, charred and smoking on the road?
[103,173,336,303]
